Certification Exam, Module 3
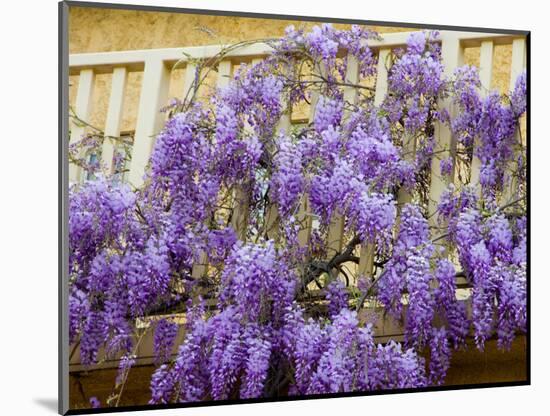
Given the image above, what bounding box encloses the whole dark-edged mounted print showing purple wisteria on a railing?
[59,1,530,414]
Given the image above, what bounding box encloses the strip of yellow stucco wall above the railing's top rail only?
[69,7,410,53]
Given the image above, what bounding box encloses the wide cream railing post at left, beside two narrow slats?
[128,59,170,187]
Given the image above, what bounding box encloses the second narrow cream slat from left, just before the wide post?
[101,67,128,175]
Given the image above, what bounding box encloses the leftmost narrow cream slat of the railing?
[69,69,95,182]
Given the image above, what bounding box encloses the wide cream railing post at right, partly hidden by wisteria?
[428,32,464,225]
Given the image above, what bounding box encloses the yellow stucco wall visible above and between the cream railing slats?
[69,7,511,131]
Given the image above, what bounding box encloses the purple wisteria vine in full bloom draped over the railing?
[69,25,528,407]
